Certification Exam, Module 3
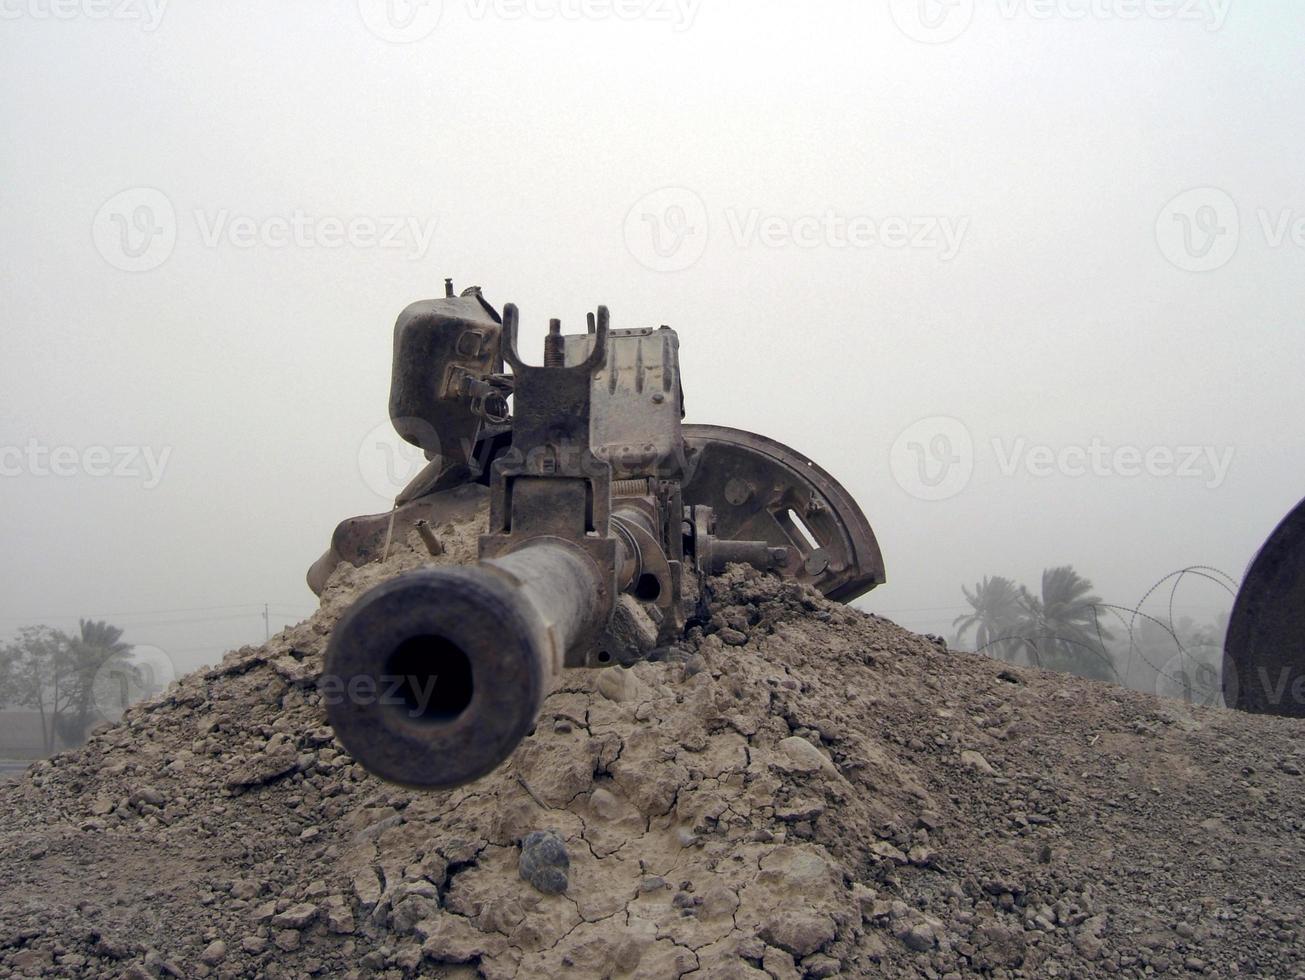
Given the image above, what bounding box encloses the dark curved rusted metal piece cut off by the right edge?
[1223,500,1305,718]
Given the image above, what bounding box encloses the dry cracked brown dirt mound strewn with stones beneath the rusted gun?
[0,514,1305,980]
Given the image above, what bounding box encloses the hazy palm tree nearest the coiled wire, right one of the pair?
[1019,565,1118,682]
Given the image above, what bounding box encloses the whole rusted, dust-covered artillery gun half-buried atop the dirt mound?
[308,282,885,789]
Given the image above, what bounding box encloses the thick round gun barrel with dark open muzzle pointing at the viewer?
[320,539,610,789]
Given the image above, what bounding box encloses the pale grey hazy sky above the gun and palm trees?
[0,0,1305,669]
